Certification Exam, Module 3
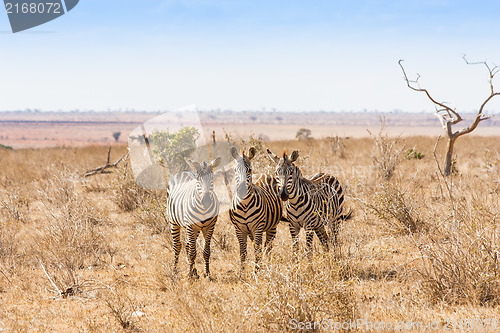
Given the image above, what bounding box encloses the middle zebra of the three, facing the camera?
[229,147,283,269]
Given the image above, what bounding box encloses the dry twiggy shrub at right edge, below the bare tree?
[417,180,500,306]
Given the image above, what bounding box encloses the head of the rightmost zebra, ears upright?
[267,149,301,201]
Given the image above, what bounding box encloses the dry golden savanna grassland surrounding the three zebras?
[0,134,500,332]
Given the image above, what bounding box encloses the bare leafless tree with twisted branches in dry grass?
[398,55,500,176]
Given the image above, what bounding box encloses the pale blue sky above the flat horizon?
[0,0,500,112]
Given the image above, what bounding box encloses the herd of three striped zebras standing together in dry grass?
[167,147,351,278]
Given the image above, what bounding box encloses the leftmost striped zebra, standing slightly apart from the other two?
[167,157,221,278]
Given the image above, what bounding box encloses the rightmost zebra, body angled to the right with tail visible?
[267,149,351,252]
